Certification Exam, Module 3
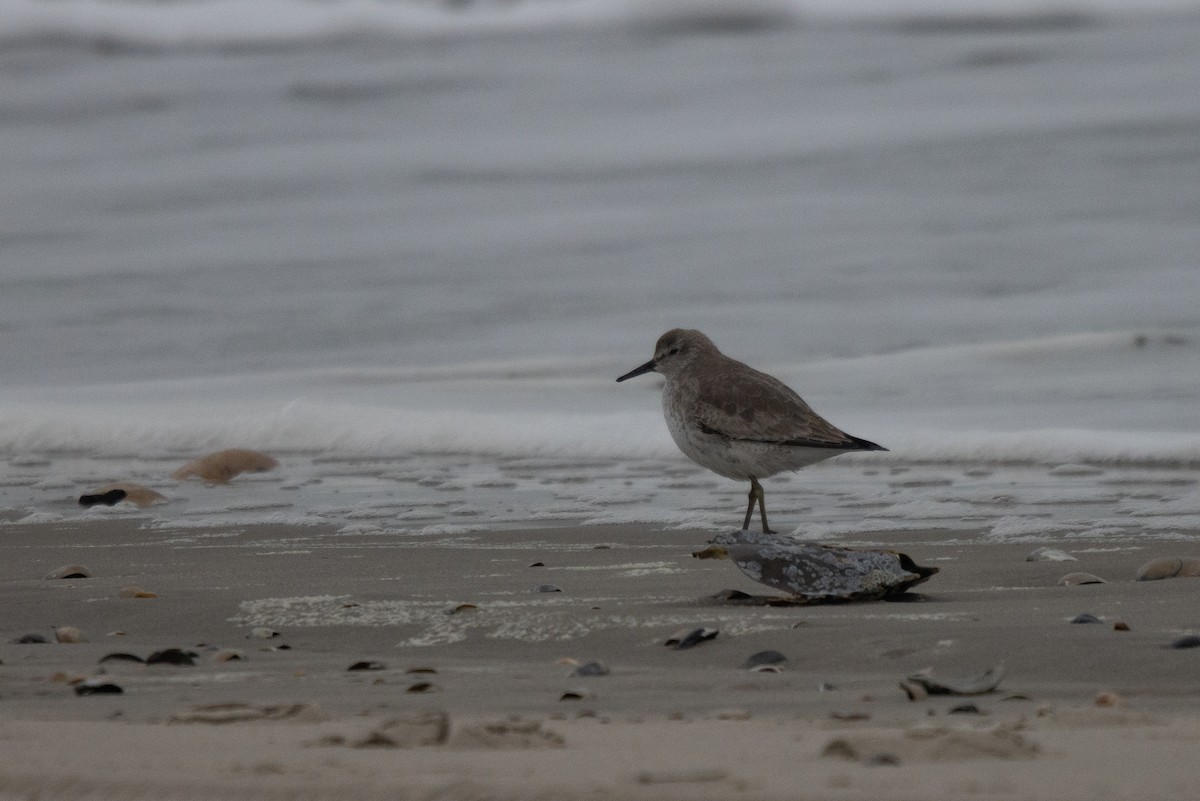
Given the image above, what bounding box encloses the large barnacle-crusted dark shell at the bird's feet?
[692,530,937,603]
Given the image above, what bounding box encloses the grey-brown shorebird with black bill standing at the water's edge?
[617,329,887,532]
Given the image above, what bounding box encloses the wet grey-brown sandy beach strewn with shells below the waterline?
[0,518,1200,801]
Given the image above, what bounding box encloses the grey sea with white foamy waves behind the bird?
[0,0,1200,538]
